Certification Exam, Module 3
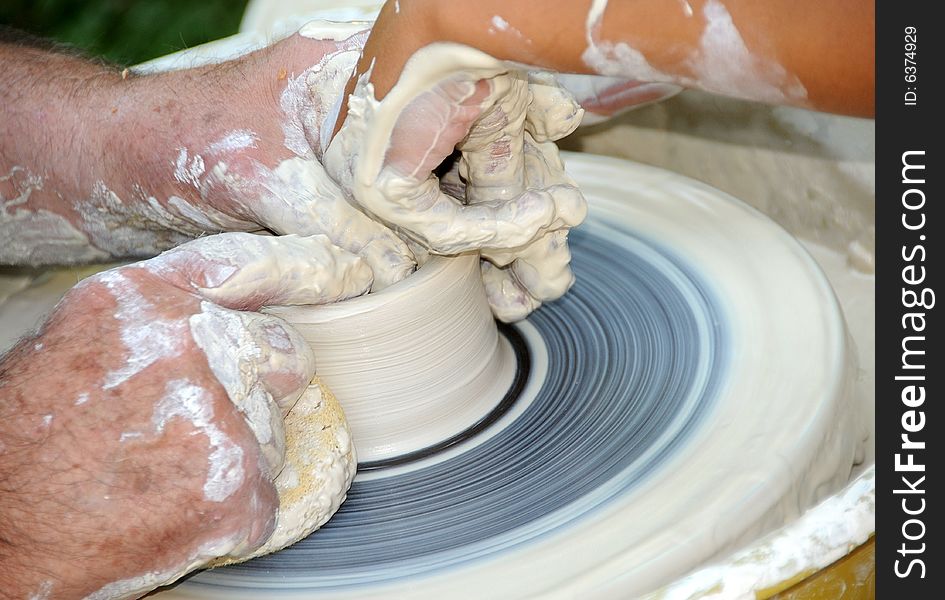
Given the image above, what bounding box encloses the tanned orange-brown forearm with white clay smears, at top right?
[359,0,874,115]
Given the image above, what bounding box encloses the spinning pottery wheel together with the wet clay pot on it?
[149,155,864,598]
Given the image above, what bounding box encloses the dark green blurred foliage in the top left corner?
[0,0,247,65]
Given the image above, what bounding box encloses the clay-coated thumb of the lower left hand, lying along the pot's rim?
[144,233,373,310]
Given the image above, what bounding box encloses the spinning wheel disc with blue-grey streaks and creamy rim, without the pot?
[171,154,853,598]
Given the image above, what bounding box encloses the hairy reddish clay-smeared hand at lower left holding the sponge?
[0,233,371,598]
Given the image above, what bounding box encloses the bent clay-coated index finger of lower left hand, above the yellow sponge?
[189,301,315,479]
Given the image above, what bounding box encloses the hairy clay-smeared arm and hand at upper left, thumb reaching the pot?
[0,27,415,289]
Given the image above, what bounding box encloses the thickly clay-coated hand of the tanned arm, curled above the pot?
[323,38,586,321]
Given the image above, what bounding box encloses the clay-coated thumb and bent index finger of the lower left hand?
[136,233,372,479]
